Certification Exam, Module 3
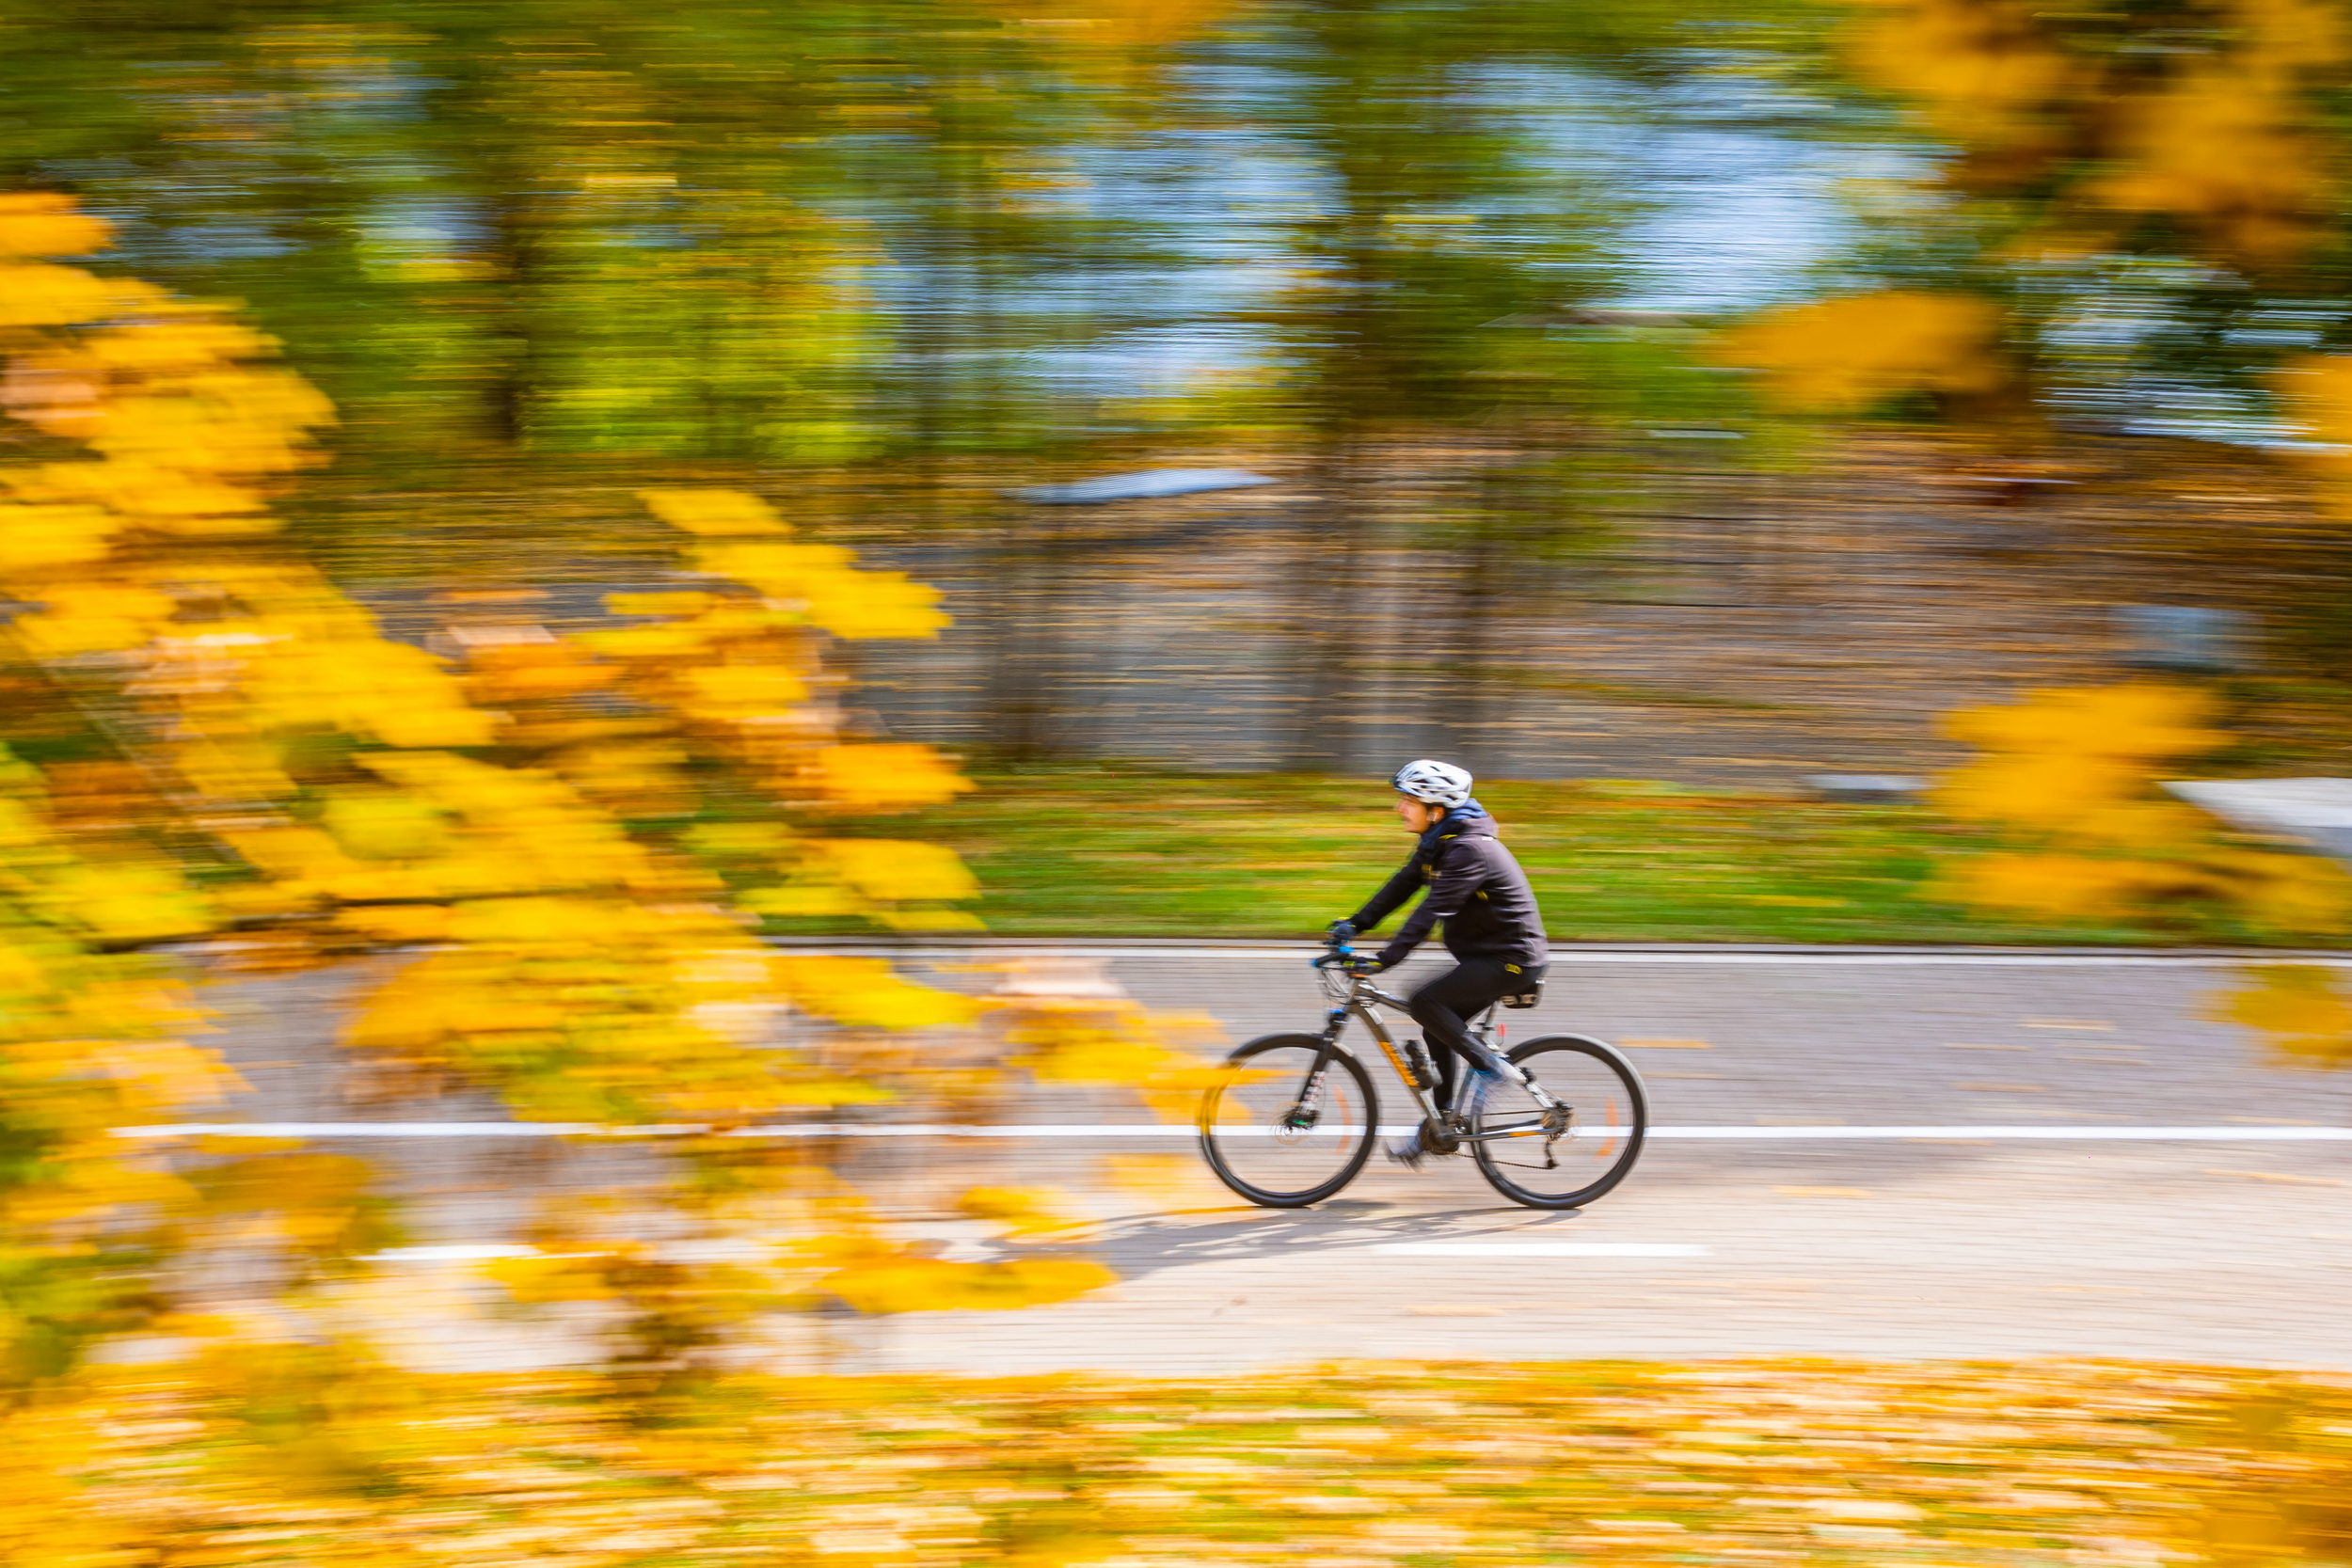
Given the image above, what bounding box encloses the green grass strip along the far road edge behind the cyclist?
[875,767,2258,942]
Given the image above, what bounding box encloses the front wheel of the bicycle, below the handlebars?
[1200,1035,1381,1209]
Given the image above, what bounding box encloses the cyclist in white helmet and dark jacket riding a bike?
[1331,759,1550,1166]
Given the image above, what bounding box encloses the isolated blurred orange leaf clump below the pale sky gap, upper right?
[1710,289,2009,414]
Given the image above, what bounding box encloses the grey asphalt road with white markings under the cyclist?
[183,942,2352,1373]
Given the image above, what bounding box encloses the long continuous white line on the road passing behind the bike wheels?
[113,1121,2352,1143]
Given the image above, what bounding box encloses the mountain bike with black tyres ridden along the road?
[1200,942,1649,1209]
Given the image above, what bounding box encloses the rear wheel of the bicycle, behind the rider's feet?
[1470,1035,1649,1209]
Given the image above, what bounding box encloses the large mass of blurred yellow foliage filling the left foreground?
[0,195,1104,1419]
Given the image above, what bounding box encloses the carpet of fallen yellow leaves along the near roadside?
[0,1363,2314,1568]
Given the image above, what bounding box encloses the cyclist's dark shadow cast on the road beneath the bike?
[1073,1199,1581,1279]
